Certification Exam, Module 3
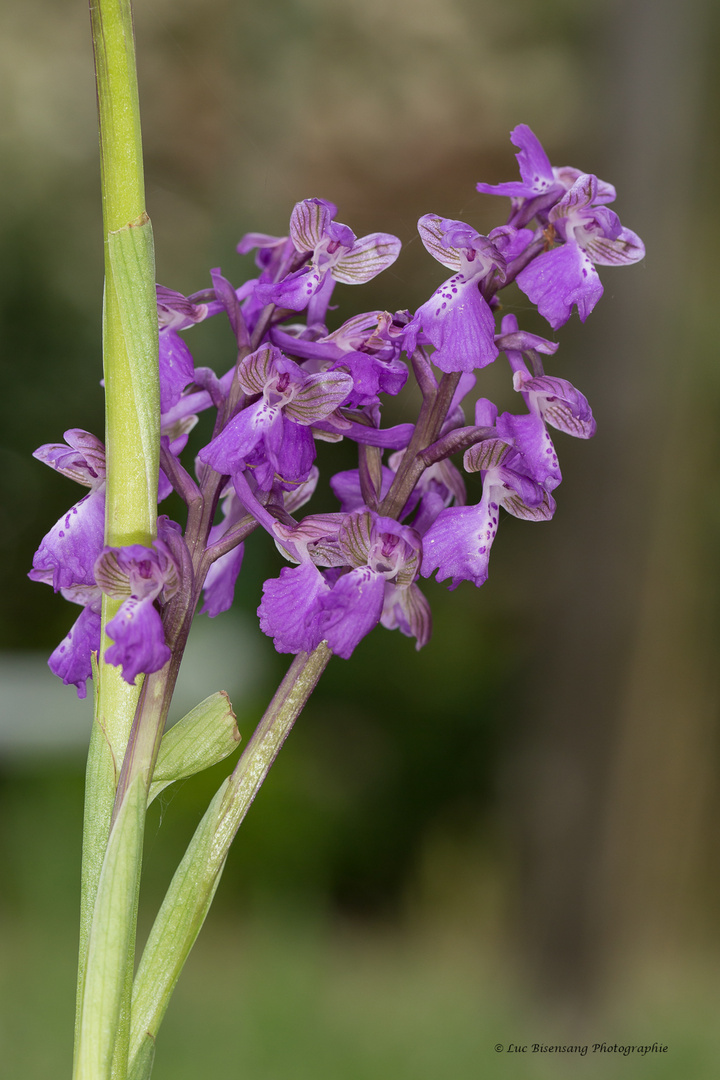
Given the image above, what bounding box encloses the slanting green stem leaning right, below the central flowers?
[127,642,332,1080]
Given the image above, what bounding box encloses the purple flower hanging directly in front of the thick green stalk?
[95,539,180,685]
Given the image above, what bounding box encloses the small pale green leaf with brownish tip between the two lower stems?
[148,690,240,806]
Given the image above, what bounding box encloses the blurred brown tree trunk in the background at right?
[508,0,718,1004]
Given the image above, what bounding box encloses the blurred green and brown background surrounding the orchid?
[0,0,720,1080]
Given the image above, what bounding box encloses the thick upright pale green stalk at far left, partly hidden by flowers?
[73,0,160,1080]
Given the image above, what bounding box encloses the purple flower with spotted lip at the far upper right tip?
[516,174,646,329]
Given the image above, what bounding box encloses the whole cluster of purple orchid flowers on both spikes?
[30,124,644,697]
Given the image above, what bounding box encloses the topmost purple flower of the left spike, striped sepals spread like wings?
[257,199,402,322]
